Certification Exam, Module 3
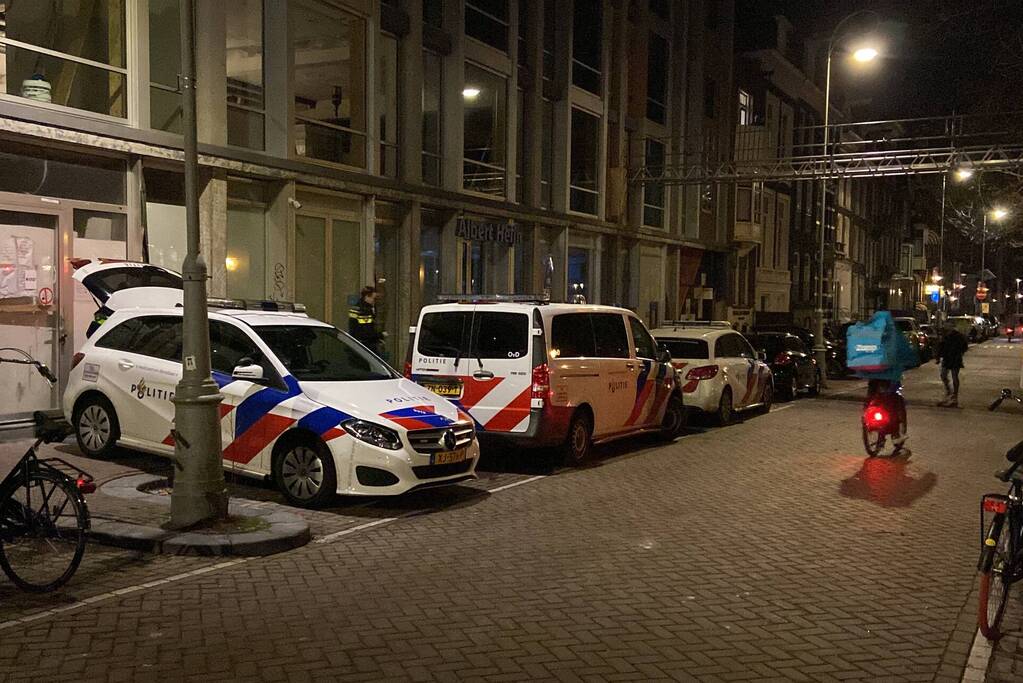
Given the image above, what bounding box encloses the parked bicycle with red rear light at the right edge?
[977,389,1023,640]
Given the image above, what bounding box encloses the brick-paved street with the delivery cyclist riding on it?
[0,345,1023,681]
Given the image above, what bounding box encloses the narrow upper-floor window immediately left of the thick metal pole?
[149,0,181,133]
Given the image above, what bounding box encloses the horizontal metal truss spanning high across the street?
[629,111,1023,185]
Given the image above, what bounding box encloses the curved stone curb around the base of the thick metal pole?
[89,474,312,557]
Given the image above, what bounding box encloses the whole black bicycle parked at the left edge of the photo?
[0,349,96,593]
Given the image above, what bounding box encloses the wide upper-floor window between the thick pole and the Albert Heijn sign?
[290,0,366,168]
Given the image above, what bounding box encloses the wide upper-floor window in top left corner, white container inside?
[0,0,128,119]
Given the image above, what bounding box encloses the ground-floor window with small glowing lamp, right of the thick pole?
[224,178,266,299]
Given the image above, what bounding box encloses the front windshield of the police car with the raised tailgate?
[255,325,398,381]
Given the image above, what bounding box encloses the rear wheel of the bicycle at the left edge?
[0,470,89,593]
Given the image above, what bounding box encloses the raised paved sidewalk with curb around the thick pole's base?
[0,440,311,555]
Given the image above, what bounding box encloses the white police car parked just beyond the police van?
[654,322,774,424]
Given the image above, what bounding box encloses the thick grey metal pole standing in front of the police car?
[169,0,227,529]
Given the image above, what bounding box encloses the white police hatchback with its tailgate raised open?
[63,262,480,507]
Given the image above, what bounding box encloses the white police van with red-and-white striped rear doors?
[405,297,683,464]
